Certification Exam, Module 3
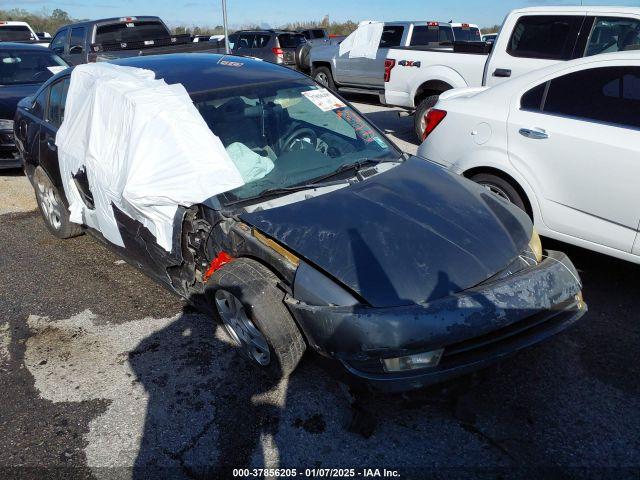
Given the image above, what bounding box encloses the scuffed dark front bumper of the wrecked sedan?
[286,251,587,392]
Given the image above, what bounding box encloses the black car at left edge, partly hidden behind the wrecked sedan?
[0,42,67,169]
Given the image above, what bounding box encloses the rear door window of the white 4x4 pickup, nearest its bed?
[507,15,584,60]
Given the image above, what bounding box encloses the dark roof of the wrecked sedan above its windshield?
[113,53,308,94]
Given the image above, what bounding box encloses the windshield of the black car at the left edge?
[0,48,67,85]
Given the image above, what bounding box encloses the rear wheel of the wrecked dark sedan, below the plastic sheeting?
[33,166,84,239]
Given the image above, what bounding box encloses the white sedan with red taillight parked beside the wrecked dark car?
[418,49,640,263]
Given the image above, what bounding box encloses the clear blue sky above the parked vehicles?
[8,0,640,27]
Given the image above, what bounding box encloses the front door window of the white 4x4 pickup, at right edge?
[585,18,640,57]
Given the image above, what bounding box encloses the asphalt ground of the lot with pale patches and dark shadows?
[0,98,640,479]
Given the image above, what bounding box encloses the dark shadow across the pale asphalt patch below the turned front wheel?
[128,307,280,479]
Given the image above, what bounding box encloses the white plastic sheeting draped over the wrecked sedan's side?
[56,63,244,251]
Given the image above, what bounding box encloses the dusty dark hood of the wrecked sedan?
[241,157,532,307]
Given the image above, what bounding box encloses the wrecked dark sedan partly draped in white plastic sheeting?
[16,54,586,391]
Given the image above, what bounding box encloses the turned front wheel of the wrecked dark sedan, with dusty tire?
[206,258,306,378]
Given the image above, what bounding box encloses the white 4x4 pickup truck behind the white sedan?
[381,6,640,139]
